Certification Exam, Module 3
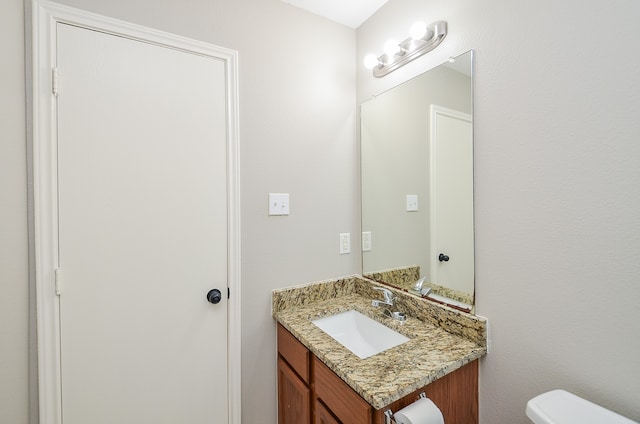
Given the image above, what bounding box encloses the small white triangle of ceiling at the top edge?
[282,0,387,28]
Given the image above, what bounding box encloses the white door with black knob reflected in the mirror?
[431,105,474,293]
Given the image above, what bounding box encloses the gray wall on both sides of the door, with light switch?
[0,0,360,424]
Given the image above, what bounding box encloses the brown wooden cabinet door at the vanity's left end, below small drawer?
[278,358,311,424]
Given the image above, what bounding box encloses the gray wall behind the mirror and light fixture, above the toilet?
[357,0,640,424]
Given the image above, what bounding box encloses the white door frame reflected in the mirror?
[429,104,473,283]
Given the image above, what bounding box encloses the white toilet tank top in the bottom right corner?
[527,390,638,424]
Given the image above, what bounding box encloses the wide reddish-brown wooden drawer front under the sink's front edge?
[313,356,372,424]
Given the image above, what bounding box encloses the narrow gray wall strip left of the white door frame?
[0,0,29,424]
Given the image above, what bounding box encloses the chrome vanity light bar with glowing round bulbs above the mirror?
[364,21,447,78]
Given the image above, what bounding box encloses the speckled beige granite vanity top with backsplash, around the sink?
[272,276,486,409]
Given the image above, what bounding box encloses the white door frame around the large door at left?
[25,0,242,424]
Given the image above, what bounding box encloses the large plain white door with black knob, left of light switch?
[56,23,228,424]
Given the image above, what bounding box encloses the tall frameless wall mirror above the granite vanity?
[360,51,474,310]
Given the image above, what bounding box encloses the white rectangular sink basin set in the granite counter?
[311,310,409,359]
